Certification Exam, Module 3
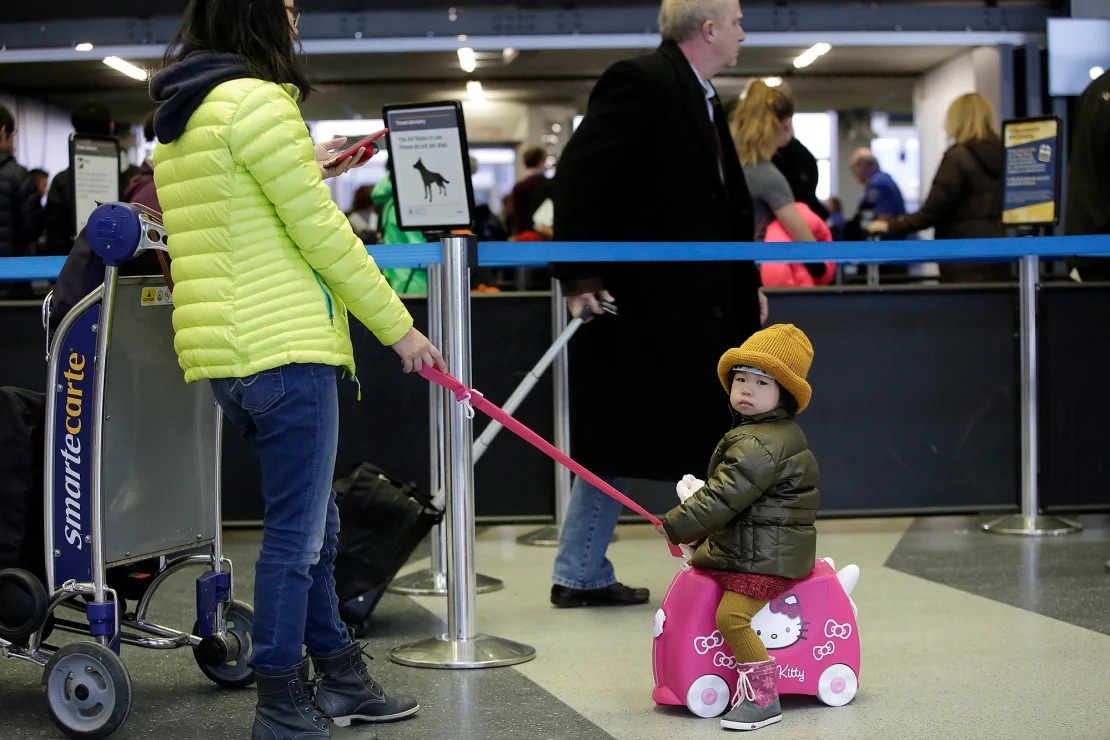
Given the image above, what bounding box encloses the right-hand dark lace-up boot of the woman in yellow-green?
[310,642,420,727]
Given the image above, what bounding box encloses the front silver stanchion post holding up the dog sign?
[390,236,536,668]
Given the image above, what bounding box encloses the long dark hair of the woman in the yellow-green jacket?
[162,0,312,99]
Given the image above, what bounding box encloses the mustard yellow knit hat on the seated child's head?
[717,324,814,414]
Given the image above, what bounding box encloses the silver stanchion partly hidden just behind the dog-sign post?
[385,264,505,596]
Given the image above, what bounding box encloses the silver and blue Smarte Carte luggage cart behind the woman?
[0,203,254,738]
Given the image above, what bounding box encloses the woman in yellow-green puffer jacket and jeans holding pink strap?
[151,0,443,740]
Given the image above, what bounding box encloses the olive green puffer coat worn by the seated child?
[663,408,820,578]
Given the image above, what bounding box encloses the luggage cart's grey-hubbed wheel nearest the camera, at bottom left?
[42,642,131,738]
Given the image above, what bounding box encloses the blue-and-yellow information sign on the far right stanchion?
[1002,118,1060,226]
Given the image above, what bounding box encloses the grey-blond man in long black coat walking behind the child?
[552,0,766,607]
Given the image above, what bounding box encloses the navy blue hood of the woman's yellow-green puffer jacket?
[150,51,252,144]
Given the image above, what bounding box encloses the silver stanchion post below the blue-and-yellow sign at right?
[982,256,1082,536]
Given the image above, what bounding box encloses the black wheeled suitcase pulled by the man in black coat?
[334,463,443,637]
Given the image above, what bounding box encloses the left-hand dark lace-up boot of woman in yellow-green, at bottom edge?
[251,658,377,740]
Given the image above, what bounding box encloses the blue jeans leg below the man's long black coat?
[552,476,632,589]
